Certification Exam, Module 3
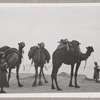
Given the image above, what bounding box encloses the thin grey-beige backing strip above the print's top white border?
[0,0,100,3]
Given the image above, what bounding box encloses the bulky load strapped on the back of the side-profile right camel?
[57,40,81,56]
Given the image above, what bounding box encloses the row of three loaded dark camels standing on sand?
[0,40,94,90]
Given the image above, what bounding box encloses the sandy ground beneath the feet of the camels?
[5,73,100,93]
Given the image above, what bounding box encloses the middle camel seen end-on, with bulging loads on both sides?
[29,43,50,86]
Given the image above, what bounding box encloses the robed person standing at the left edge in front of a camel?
[0,52,8,93]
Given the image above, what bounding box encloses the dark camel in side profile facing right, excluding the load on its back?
[51,46,94,90]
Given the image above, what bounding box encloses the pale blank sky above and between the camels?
[0,4,100,78]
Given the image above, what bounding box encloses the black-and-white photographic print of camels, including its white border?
[0,4,100,95]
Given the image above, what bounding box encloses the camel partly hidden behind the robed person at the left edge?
[0,42,25,87]
